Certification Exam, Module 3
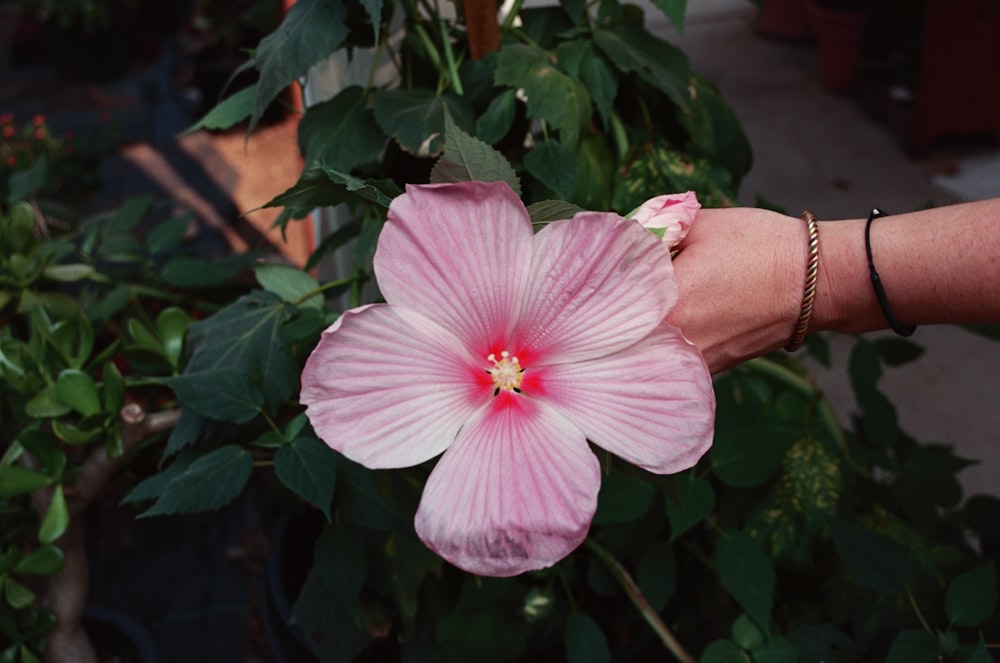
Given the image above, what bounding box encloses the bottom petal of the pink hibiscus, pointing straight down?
[416,392,601,576]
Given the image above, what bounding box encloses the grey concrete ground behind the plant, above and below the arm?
[647,0,1000,495]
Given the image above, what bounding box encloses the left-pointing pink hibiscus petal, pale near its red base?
[300,304,493,468]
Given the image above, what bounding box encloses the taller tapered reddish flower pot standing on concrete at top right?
[806,0,868,94]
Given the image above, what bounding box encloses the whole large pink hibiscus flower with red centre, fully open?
[301,182,715,576]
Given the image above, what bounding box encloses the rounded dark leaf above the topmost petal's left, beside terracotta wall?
[299,85,386,171]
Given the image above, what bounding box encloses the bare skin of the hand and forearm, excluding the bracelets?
[667,199,1000,373]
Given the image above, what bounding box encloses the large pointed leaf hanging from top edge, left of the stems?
[247,0,348,133]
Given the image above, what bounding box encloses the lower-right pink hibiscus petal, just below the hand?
[542,323,715,474]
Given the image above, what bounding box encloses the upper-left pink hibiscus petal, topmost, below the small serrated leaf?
[375,182,532,356]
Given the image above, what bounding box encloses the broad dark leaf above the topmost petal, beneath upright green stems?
[373,89,475,157]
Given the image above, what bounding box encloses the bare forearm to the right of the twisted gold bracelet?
[810,200,1000,333]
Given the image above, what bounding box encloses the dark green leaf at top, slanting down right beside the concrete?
[594,24,692,111]
